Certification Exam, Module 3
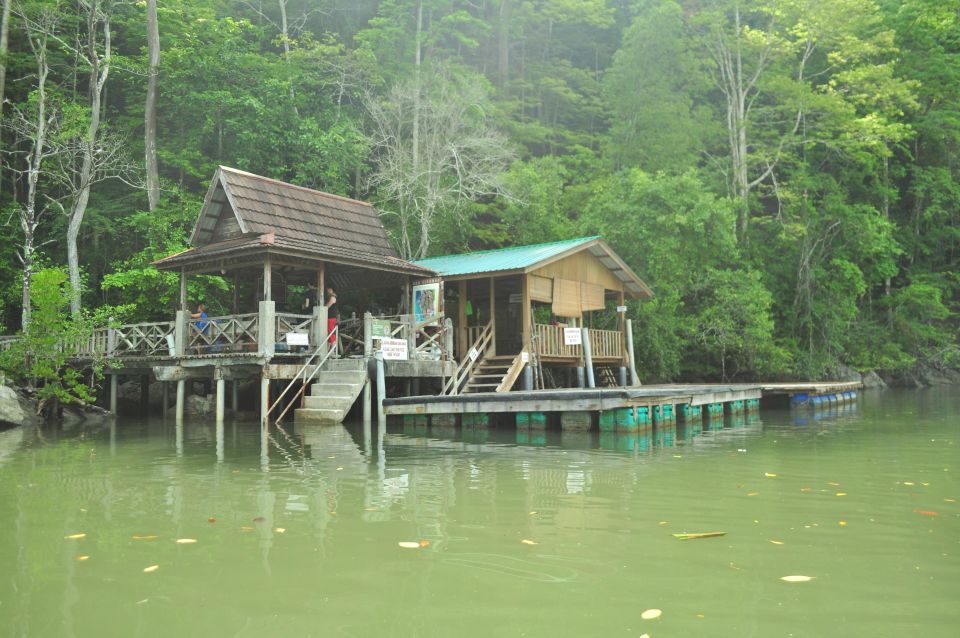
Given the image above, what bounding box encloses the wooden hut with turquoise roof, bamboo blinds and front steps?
[415,236,653,394]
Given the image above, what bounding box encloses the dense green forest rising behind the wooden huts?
[0,0,960,381]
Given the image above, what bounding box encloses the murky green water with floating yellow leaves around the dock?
[0,391,960,638]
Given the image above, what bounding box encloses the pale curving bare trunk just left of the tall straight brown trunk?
[67,2,111,318]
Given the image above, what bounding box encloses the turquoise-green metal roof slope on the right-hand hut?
[413,235,600,277]
